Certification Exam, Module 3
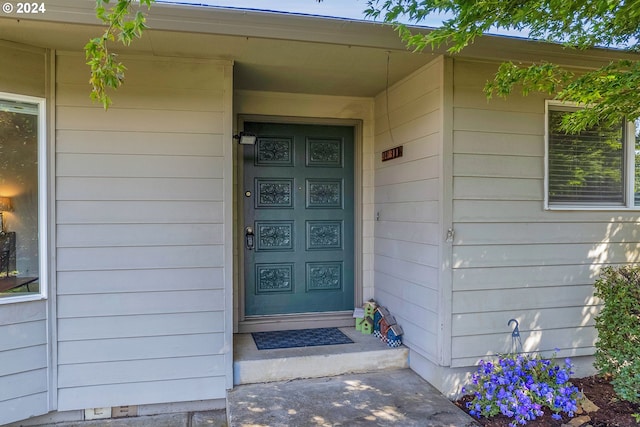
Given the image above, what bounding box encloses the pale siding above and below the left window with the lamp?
[0,41,49,425]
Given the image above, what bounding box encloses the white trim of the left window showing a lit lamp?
[0,92,49,305]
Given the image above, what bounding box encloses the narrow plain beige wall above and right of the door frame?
[234,91,374,328]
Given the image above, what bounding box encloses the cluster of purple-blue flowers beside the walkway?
[462,354,581,427]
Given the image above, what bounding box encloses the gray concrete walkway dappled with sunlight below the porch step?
[227,369,479,427]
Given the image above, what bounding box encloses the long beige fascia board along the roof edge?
[16,0,638,61]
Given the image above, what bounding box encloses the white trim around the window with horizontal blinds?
[544,99,640,211]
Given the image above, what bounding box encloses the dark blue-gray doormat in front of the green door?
[251,328,353,350]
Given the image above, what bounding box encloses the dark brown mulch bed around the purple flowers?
[455,376,640,427]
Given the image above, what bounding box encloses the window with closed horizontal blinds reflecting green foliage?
[547,105,640,207]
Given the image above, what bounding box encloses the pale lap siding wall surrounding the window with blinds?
[452,60,640,366]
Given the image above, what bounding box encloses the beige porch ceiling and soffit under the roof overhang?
[0,18,434,97]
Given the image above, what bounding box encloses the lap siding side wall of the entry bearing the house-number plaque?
[374,59,443,360]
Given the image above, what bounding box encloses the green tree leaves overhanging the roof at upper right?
[364,0,640,132]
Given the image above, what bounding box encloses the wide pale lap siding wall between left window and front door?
[56,53,232,410]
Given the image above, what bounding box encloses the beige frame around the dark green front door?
[233,114,363,333]
